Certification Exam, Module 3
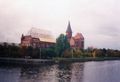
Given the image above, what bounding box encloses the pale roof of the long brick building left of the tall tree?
[28,28,55,43]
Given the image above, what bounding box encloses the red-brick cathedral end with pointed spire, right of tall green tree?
[66,22,84,49]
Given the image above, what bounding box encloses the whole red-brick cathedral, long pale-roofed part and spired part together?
[21,22,84,49]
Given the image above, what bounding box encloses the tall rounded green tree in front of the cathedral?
[56,34,70,57]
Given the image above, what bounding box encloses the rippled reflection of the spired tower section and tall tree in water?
[58,63,84,82]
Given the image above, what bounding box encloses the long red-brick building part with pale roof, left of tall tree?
[21,28,55,48]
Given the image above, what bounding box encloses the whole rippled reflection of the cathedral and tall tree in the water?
[19,63,84,82]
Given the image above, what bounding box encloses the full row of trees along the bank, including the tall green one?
[0,34,120,59]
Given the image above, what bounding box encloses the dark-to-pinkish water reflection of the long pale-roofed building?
[19,65,57,82]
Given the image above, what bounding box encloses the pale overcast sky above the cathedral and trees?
[0,0,120,49]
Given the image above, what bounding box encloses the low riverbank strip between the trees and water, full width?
[0,57,120,65]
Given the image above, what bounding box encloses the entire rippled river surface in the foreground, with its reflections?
[0,61,120,82]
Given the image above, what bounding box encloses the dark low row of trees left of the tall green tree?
[0,43,55,59]
